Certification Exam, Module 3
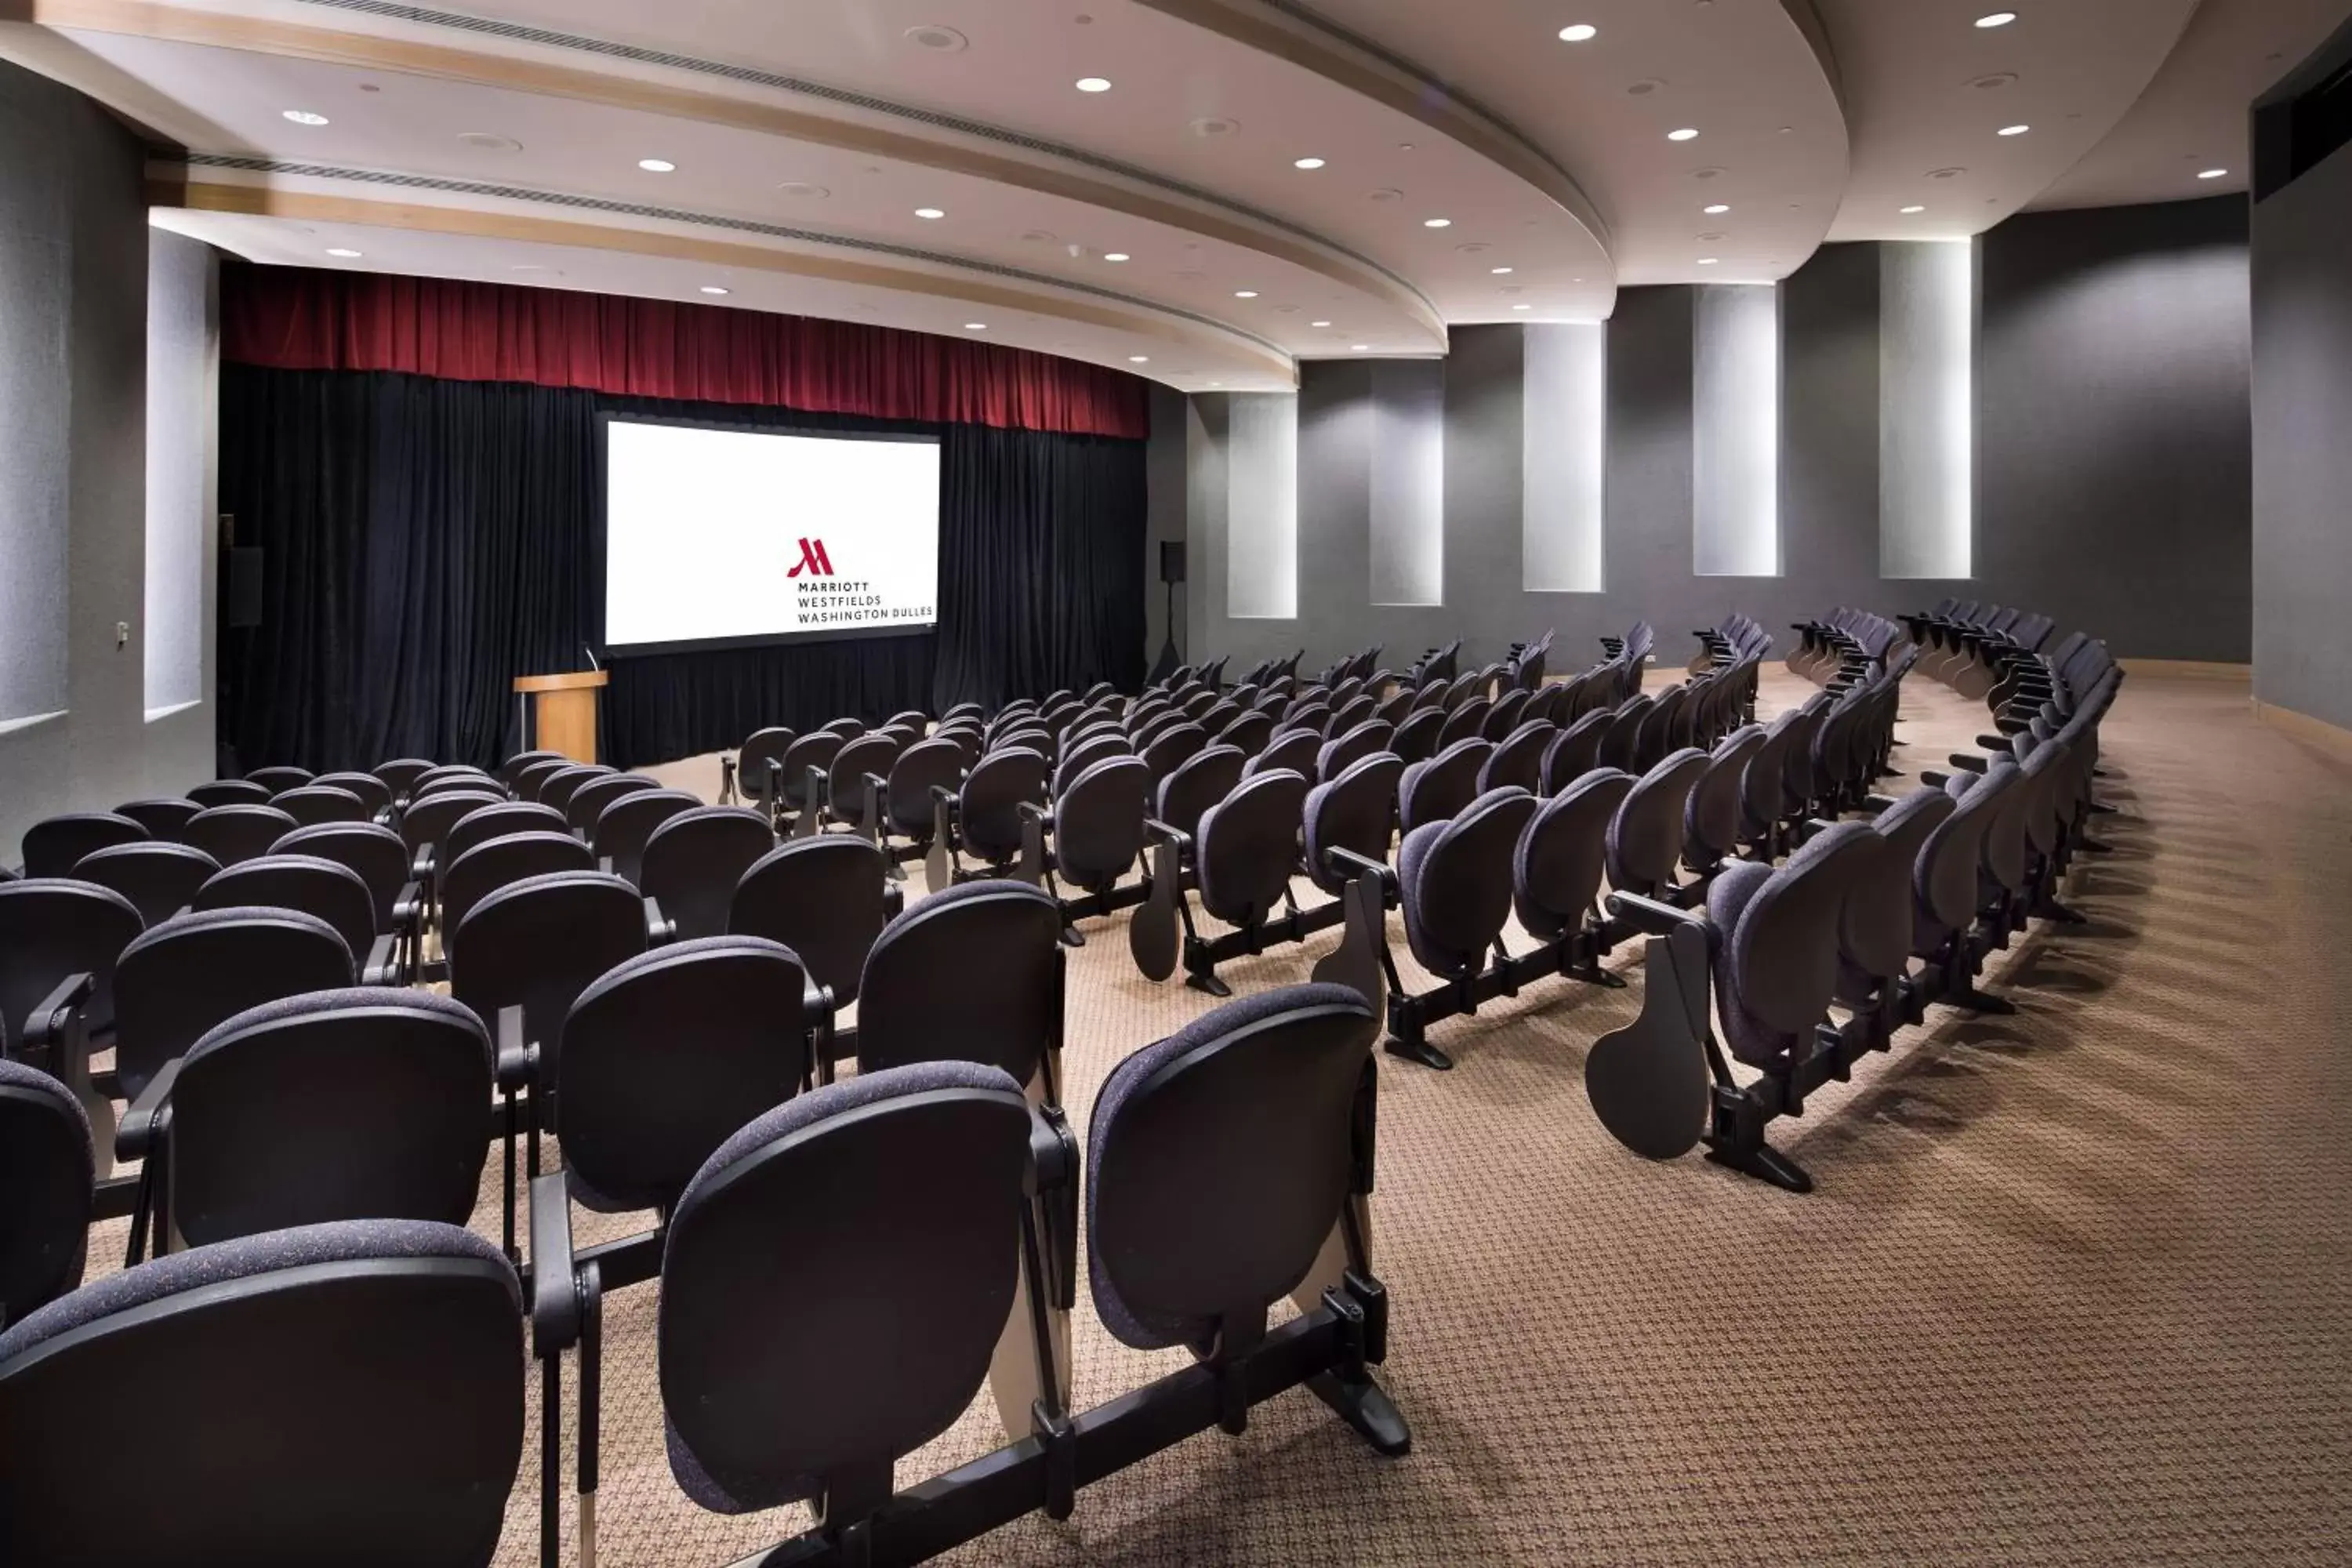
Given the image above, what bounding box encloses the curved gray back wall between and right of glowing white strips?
[1185,200,2251,681]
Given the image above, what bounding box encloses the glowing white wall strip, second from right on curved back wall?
[1691,285,1780,576]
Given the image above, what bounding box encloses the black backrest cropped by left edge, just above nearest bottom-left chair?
[0,1058,99,1335]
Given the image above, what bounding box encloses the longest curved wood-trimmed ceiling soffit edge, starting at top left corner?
[24,0,1446,343]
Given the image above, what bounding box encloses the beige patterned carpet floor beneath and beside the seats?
[101,670,2352,1568]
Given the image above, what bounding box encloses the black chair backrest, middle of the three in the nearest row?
[659,1060,1033,1514]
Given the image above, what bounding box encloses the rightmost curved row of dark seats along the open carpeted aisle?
[1585,607,2122,1192]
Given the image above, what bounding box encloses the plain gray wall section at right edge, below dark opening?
[2253,146,2352,727]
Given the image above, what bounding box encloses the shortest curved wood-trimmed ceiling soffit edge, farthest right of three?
[1134,0,1616,259]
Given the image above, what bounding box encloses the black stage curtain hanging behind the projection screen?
[221,365,1145,769]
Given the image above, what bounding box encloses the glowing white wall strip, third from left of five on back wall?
[1519,322,1609,593]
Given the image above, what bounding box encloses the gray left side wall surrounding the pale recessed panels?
[0,64,214,862]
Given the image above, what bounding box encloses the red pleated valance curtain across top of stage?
[221,266,1150,440]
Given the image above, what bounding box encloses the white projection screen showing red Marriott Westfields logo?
[604,419,938,654]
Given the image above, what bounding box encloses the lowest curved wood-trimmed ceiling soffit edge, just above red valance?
[165,175,1296,383]
